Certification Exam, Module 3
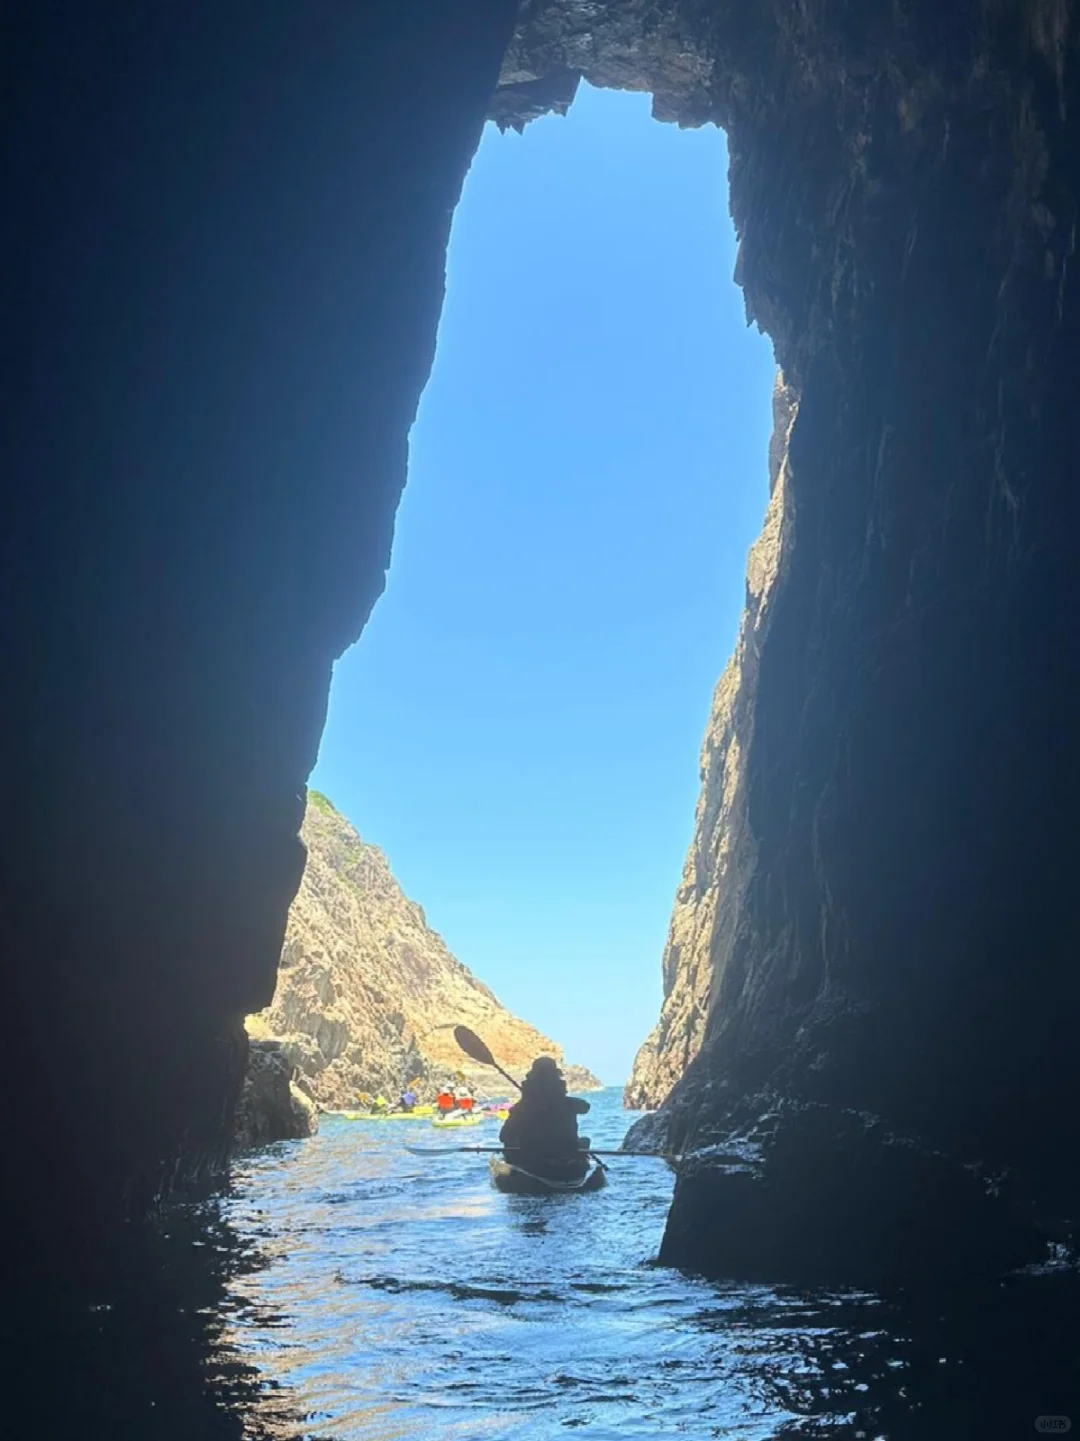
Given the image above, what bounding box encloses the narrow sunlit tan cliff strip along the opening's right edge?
[624,375,797,1110]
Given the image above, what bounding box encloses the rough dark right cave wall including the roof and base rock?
[496,0,1080,1280]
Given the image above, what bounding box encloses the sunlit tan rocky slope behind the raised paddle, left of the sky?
[249,791,598,1108]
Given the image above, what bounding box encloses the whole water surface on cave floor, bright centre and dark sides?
[31,1091,1080,1441]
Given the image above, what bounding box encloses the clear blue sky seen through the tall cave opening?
[311,86,773,1082]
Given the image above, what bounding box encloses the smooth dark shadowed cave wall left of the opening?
[0,0,512,1256]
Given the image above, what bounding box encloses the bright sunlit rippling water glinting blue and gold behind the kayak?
[213,1092,869,1441]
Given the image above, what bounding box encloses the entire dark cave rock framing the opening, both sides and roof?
[8,0,1080,1296]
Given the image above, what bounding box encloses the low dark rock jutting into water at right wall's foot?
[651,1098,1047,1291]
